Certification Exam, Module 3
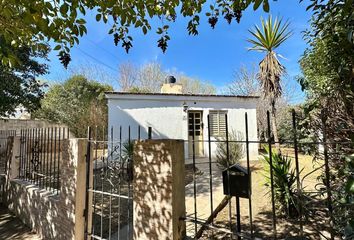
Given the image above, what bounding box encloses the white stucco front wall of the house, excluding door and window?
[107,93,258,157]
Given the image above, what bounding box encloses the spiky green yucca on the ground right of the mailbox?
[262,149,299,217]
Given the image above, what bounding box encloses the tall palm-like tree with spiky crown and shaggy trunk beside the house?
[247,16,292,152]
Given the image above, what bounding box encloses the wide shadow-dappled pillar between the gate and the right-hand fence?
[133,140,186,240]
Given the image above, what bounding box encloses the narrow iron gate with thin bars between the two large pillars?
[85,128,133,240]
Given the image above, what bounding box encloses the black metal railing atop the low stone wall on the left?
[18,127,70,194]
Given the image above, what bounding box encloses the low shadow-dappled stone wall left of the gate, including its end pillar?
[4,137,87,240]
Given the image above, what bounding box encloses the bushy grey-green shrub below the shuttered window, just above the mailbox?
[216,130,244,170]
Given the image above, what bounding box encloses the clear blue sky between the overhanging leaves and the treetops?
[44,0,311,102]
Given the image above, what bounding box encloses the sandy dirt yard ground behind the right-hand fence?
[191,149,329,240]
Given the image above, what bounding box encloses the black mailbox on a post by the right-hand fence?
[222,164,250,198]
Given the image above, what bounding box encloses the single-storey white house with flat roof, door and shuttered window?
[106,78,258,157]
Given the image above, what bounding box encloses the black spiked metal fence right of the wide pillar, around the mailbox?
[184,112,354,239]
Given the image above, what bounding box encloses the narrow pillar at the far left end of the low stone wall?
[6,137,21,179]
